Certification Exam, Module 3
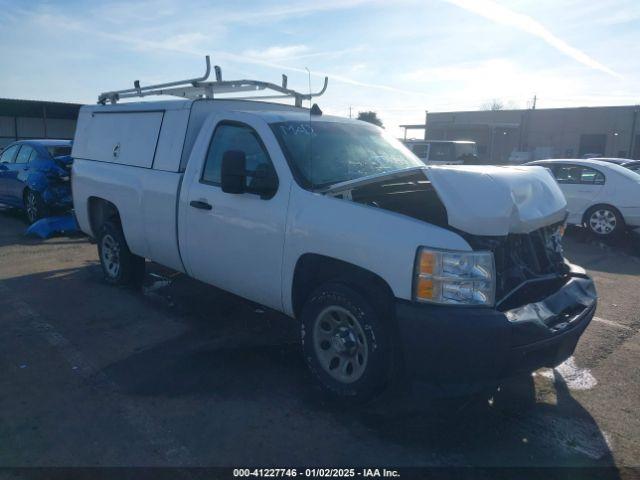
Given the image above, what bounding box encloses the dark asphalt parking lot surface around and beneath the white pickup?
[0,211,640,470]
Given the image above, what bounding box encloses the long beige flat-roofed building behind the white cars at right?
[401,105,640,164]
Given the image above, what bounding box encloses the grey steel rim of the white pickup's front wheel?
[313,305,369,383]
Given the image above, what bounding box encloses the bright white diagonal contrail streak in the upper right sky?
[444,0,621,78]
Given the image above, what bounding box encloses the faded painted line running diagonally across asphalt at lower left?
[0,283,195,466]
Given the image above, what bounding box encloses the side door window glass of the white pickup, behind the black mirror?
[202,123,275,191]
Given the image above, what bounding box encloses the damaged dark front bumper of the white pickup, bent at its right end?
[396,267,597,386]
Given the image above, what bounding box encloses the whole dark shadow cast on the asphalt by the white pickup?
[106,266,616,468]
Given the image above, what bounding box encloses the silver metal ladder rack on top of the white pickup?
[98,55,329,107]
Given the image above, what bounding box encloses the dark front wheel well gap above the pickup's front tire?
[291,253,393,318]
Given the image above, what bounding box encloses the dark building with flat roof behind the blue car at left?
[0,98,80,149]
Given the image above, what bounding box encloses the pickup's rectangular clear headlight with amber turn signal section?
[413,247,496,306]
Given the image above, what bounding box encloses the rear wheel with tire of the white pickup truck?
[97,221,145,286]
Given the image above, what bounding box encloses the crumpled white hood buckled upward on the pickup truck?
[425,165,567,236]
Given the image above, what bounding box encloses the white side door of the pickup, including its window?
[180,119,289,309]
